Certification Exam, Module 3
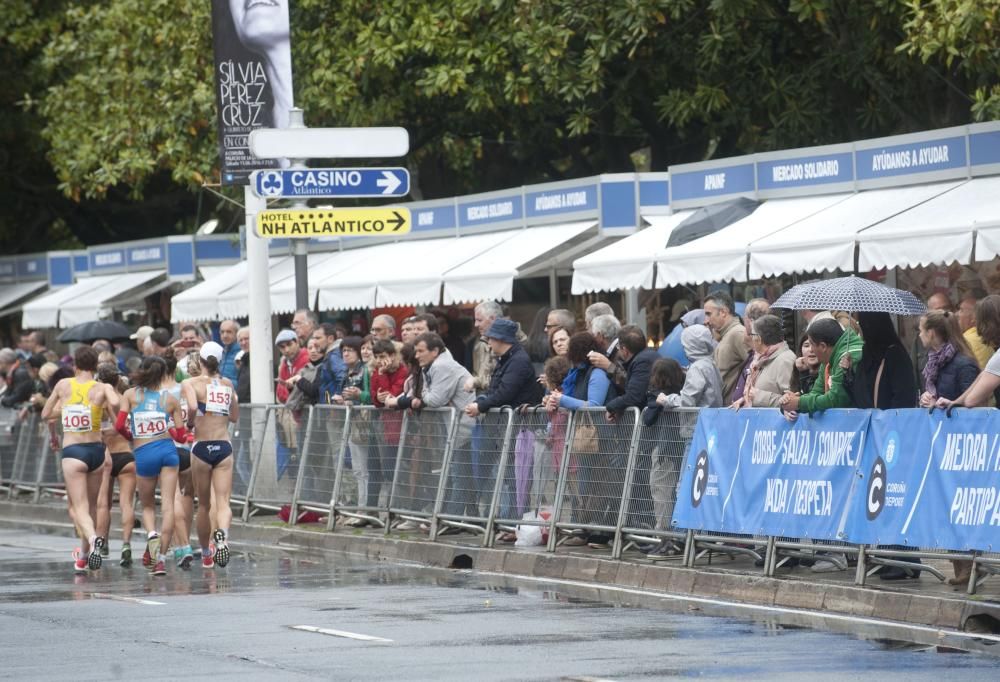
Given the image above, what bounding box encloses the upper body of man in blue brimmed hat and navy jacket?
[465,317,541,417]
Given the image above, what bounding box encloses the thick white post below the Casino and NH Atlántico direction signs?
[249,185,274,405]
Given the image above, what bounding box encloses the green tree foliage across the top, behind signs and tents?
[0,0,1000,251]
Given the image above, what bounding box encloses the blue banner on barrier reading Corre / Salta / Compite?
[673,409,869,540]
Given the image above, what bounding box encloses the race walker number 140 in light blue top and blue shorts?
[115,355,187,575]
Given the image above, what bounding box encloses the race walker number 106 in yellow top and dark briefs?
[42,346,119,573]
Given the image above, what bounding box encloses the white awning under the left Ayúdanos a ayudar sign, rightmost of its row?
[444,220,597,305]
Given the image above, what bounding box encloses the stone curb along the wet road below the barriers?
[0,501,1000,630]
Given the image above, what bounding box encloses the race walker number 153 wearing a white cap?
[183,341,240,568]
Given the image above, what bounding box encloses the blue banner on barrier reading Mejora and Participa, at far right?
[847,409,1000,551]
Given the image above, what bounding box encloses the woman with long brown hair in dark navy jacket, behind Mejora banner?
[920,310,979,407]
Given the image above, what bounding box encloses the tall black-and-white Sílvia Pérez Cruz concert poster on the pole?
[212,0,293,185]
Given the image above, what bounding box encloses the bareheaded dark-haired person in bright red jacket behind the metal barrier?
[368,339,409,507]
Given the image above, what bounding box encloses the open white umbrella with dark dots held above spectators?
[771,276,927,315]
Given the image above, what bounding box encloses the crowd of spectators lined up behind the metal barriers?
[0,292,1000,584]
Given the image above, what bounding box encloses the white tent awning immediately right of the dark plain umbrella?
[656,194,851,288]
